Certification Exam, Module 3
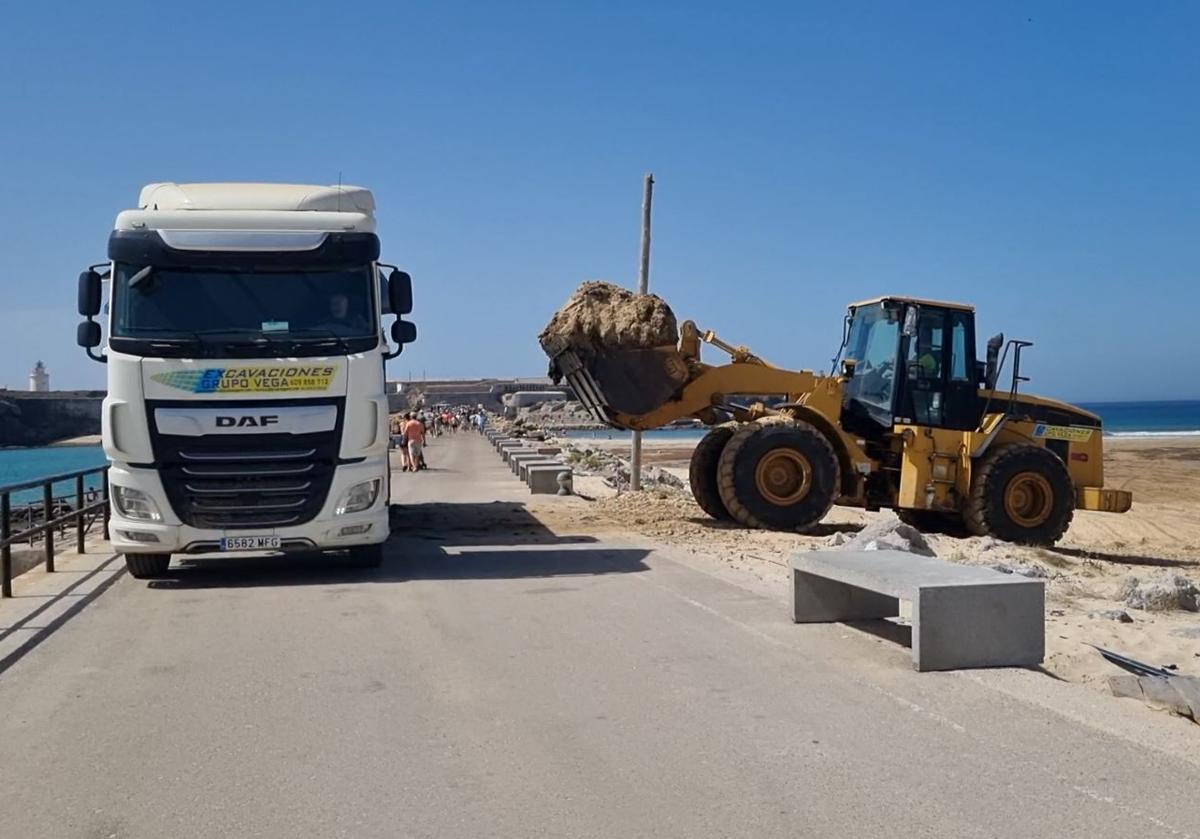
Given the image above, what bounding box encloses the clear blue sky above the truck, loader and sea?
[0,0,1200,400]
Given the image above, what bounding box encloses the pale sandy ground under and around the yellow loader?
[539,437,1200,691]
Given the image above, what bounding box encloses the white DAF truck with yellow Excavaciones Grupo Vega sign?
[78,184,416,579]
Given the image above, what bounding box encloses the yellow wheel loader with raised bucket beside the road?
[546,296,1133,545]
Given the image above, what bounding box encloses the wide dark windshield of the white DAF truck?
[112,263,379,356]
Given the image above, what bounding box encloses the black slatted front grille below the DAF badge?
[151,398,341,529]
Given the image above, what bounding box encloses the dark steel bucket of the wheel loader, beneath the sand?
[551,347,688,429]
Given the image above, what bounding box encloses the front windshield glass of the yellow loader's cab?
[844,305,902,427]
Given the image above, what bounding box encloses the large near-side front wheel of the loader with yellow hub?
[718,420,841,531]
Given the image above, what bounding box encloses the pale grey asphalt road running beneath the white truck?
[0,437,1200,838]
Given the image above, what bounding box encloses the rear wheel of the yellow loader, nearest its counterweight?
[965,444,1075,545]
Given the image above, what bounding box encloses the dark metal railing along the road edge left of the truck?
[0,466,110,598]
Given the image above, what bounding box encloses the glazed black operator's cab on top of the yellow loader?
[842,298,980,437]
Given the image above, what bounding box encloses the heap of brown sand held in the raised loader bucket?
[538,280,679,358]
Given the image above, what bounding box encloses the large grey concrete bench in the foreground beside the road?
[792,551,1045,671]
